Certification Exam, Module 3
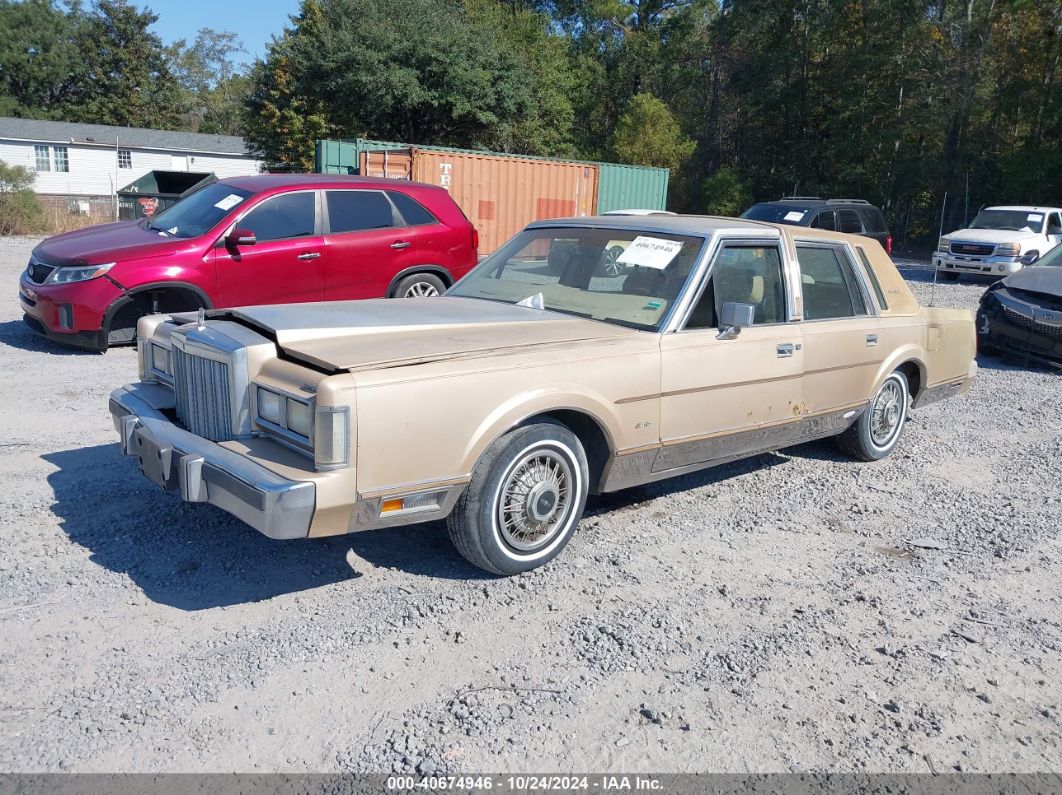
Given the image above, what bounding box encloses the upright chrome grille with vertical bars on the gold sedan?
[170,346,235,442]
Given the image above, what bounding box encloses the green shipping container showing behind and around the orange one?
[314,138,669,213]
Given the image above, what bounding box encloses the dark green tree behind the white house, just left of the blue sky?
[72,0,181,128]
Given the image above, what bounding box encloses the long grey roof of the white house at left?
[0,117,249,155]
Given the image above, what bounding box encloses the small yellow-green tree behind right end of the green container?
[610,93,697,172]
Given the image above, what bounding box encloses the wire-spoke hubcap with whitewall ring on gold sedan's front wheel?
[495,444,579,556]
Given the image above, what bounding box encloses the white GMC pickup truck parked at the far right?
[932,207,1062,281]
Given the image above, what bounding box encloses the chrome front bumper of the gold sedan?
[110,384,316,538]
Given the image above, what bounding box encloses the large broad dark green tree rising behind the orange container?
[246,0,565,166]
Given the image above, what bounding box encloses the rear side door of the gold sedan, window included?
[795,239,885,415]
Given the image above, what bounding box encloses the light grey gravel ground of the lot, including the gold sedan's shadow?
[0,238,1062,773]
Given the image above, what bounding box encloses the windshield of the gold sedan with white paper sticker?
[446,227,704,331]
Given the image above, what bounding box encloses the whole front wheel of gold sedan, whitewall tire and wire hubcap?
[446,421,589,575]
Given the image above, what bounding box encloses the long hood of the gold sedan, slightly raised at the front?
[221,296,643,370]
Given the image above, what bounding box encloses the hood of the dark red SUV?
[33,221,190,266]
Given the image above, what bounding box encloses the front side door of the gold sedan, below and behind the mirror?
[653,240,804,471]
